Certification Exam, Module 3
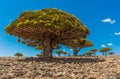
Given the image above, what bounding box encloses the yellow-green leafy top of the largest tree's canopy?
[6,8,89,34]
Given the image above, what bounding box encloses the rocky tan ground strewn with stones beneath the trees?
[0,56,120,79]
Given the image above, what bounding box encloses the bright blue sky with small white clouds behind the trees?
[0,0,120,56]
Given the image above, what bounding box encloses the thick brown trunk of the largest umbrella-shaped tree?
[43,38,52,58]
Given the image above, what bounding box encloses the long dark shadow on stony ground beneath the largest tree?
[18,57,105,64]
